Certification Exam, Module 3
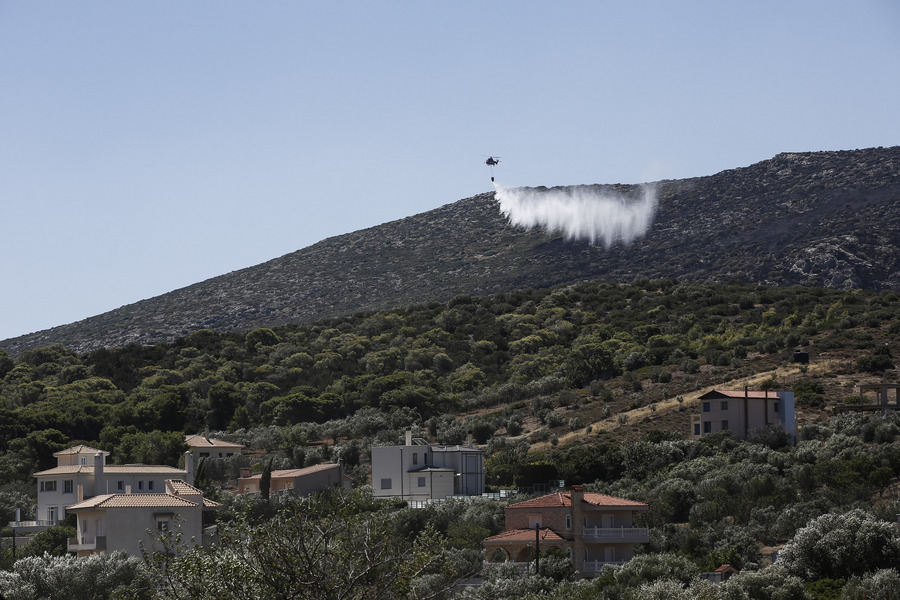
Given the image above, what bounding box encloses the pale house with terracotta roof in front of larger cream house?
[68,479,220,557]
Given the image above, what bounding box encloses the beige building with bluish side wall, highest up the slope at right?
[691,389,797,441]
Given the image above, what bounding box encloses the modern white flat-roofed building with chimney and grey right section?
[372,431,484,502]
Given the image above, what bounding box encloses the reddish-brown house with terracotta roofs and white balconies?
[483,485,650,577]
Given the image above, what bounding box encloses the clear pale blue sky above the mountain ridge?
[0,0,900,339]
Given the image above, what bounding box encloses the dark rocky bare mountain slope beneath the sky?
[0,147,900,354]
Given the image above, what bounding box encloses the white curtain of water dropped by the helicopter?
[494,183,657,249]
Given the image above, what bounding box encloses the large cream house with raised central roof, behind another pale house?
[34,445,193,526]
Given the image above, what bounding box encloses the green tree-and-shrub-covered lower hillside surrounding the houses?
[0,280,900,600]
